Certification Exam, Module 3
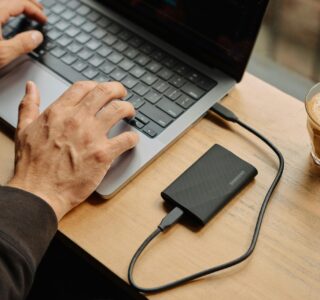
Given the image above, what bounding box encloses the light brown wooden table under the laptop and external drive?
[0,74,320,300]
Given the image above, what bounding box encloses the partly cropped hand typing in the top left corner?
[0,0,47,69]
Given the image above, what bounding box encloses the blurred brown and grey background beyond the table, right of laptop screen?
[248,0,320,100]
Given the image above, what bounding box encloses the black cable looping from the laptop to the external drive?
[128,103,284,293]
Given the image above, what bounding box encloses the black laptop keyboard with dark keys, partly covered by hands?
[3,0,217,138]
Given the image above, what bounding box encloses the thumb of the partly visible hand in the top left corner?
[0,30,43,67]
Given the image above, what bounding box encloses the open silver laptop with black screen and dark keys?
[0,0,268,198]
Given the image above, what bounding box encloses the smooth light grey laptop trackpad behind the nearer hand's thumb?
[0,60,70,127]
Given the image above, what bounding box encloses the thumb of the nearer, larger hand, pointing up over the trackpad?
[17,81,40,135]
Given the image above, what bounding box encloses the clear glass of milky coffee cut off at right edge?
[305,83,320,167]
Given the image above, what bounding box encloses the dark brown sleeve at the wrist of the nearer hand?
[0,187,57,300]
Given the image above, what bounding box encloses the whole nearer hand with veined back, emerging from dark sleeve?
[8,82,138,220]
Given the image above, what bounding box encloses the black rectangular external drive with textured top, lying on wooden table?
[161,145,258,225]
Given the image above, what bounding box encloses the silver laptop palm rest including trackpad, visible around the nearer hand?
[0,59,164,198]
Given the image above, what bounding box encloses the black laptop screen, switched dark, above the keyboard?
[102,0,268,81]
